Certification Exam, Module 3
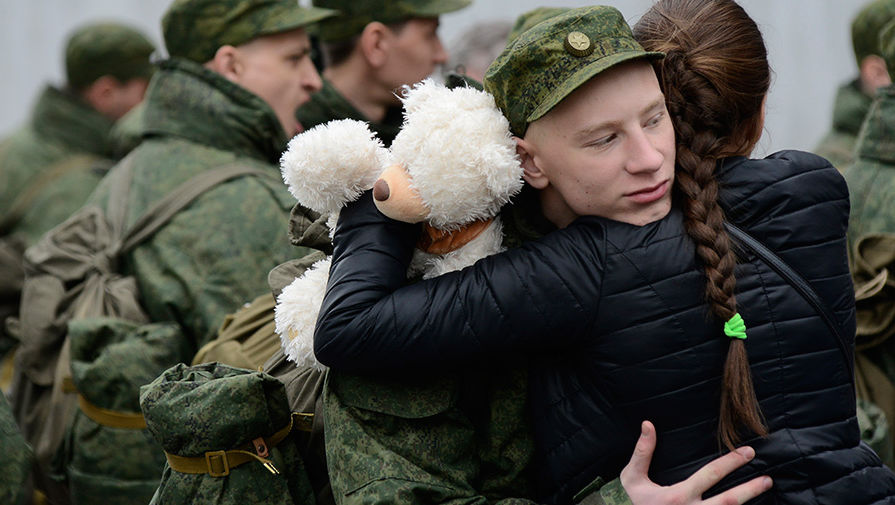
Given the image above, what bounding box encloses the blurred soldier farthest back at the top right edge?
[815,0,895,171]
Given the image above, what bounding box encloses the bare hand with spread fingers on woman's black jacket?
[620,421,772,505]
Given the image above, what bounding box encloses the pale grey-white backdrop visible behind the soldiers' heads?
[0,0,867,158]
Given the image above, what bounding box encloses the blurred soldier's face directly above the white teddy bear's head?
[380,18,448,93]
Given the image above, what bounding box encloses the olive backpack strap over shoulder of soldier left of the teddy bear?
[118,164,275,254]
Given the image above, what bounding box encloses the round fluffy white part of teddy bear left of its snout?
[280,119,389,214]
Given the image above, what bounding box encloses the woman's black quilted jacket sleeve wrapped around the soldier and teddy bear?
[314,193,605,372]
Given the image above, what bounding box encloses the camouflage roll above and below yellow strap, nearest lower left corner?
[64,318,195,505]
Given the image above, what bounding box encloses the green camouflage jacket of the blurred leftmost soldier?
[0,87,112,355]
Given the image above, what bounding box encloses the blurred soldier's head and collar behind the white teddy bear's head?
[297,0,472,145]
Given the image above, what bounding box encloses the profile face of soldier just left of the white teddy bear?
[231,29,323,137]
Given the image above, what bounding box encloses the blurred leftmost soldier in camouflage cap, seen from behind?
[0,22,155,366]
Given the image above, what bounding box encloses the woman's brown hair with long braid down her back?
[634,0,771,450]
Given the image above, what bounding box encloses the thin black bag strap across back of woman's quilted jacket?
[724,222,855,384]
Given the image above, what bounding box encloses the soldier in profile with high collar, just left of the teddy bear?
[8,0,331,503]
